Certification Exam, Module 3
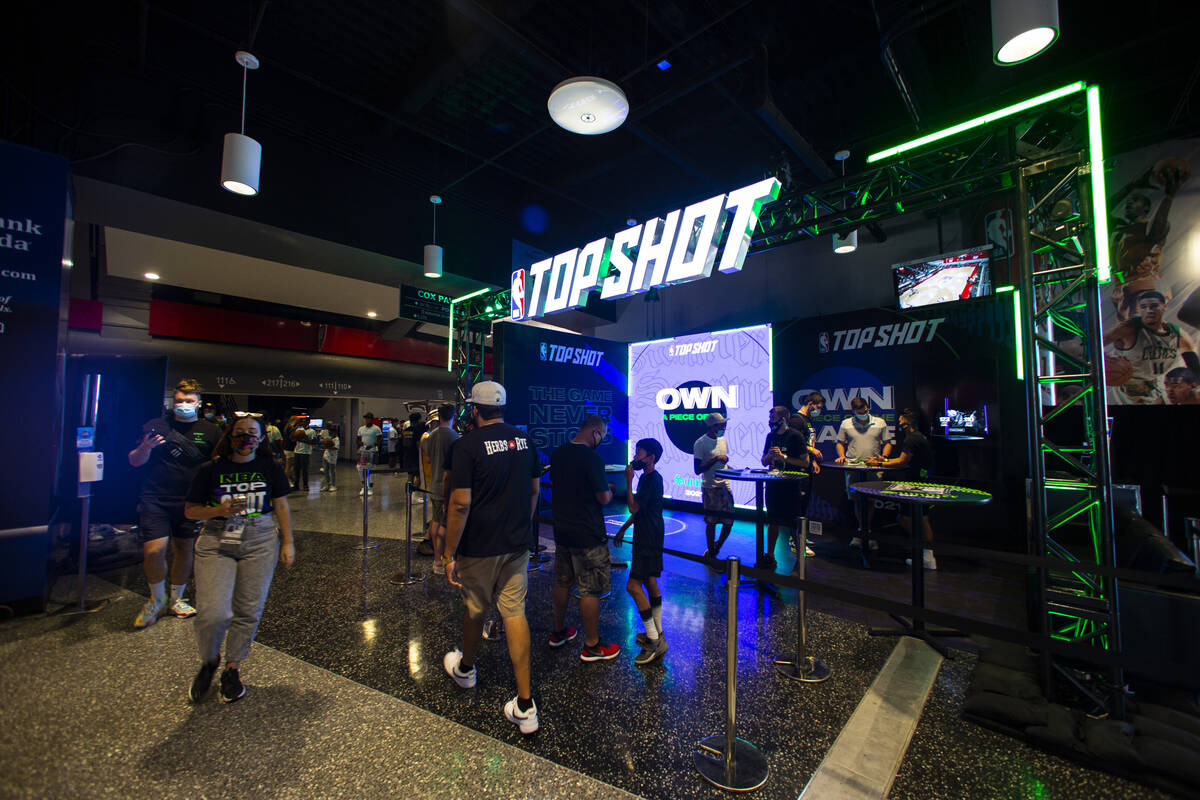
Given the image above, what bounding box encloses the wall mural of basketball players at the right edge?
[1100,139,1200,405]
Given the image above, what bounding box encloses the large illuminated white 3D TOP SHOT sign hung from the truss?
[511,178,779,319]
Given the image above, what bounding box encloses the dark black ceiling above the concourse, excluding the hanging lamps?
[7,0,1200,285]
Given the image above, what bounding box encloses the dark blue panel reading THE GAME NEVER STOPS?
[494,323,629,464]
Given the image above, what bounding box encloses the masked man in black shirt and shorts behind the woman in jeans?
[128,378,221,627]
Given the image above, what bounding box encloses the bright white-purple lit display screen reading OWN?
[629,325,774,507]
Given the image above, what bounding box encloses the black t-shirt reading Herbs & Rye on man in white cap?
[450,422,541,558]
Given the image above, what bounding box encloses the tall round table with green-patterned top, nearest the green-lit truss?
[850,481,991,656]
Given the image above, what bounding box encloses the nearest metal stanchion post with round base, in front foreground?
[691,555,768,792]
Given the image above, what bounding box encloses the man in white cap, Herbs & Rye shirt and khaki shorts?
[442,380,541,734]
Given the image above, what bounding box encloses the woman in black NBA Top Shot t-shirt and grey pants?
[184,413,295,703]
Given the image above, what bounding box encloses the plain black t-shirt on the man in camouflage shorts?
[550,441,608,548]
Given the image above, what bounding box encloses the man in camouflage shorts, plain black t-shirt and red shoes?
[550,414,620,661]
